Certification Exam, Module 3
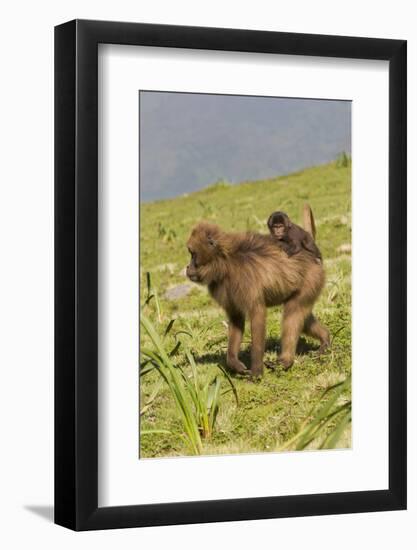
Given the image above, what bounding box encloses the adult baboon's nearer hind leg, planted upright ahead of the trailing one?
[279,298,311,369]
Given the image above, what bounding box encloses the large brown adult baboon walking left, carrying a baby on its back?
[186,205,329,377]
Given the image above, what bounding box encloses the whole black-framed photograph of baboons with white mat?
[55,20,406,530]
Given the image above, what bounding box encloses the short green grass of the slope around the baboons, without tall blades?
[140,160,351,457]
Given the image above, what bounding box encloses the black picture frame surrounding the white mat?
[55,20,407,531]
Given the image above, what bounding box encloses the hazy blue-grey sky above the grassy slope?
[140,92,351,201]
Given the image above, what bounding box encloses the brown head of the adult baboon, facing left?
[186,227,217,284]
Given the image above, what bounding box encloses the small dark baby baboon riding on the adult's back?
[268,212,322,261]
